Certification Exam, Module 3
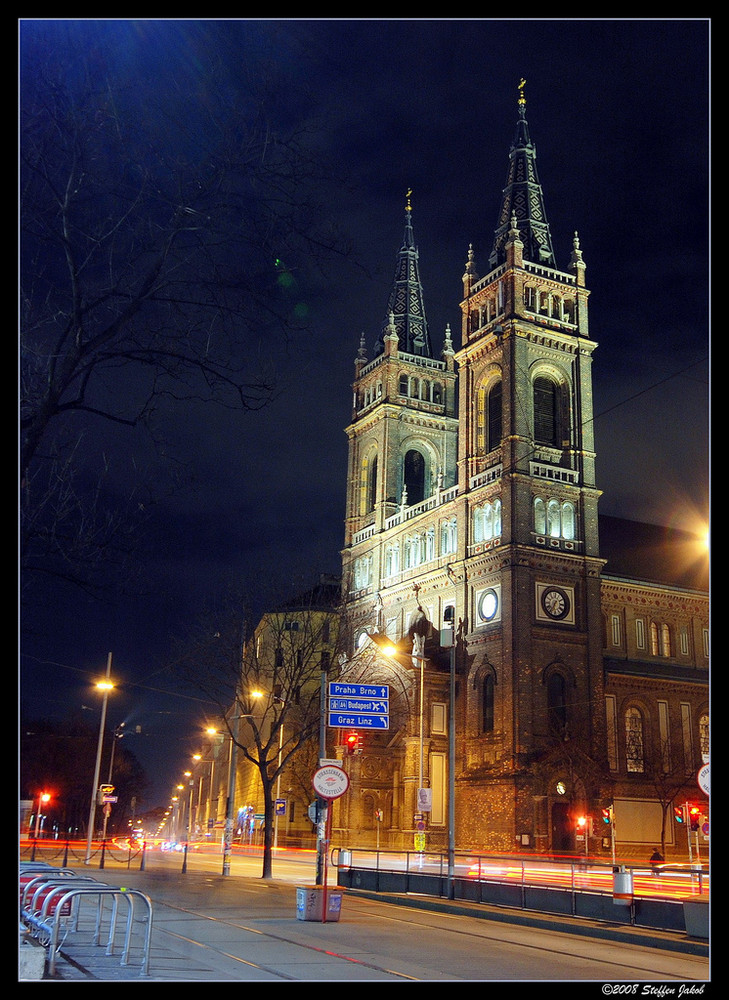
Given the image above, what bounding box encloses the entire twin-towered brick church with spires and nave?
[330,84,709,857]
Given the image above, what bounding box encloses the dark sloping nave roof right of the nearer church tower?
[599,514,709,593]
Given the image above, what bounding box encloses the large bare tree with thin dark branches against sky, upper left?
[19,29,352,582]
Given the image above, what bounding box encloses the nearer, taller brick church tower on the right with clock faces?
[456,81,604,849]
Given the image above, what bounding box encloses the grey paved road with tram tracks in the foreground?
[24,860,710,992]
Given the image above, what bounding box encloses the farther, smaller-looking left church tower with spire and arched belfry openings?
[344,192,458,627]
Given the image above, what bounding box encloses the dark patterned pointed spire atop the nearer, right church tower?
[489,80,557,269]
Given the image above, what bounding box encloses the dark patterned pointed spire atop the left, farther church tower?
[375,190,433,358]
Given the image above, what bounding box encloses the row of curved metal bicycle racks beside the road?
[20,866,152,976]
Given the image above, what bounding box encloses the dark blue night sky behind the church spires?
[19,19,711,807]
